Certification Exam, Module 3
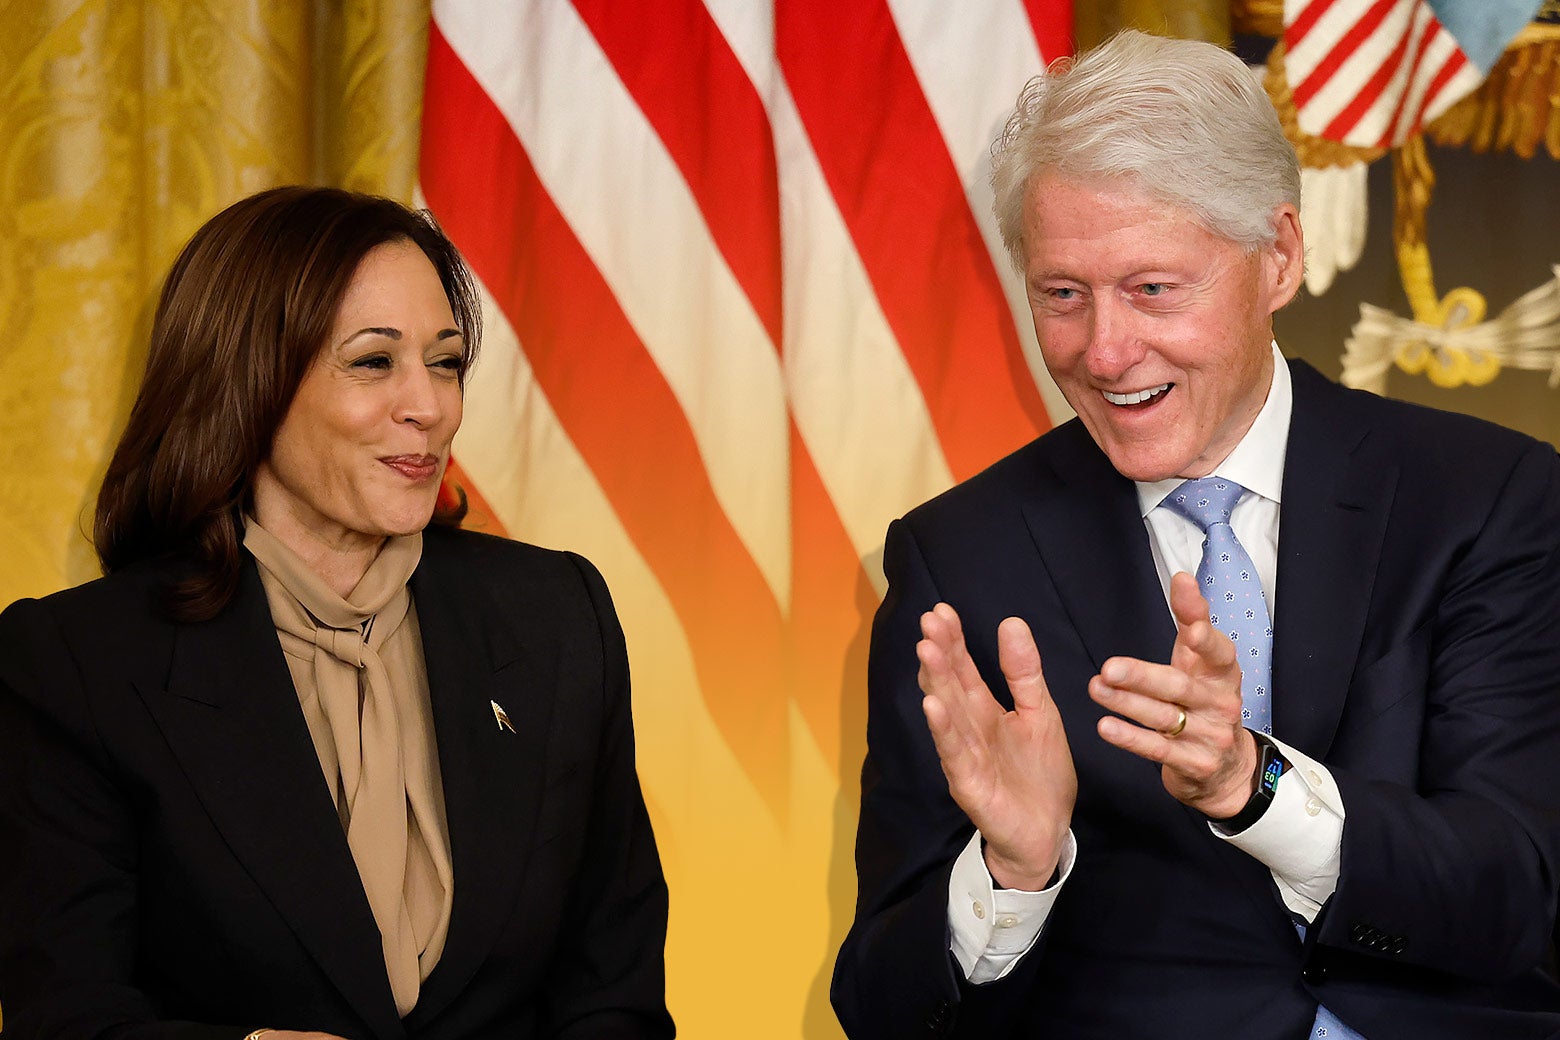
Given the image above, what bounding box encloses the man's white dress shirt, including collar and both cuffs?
[948,343,1345,982]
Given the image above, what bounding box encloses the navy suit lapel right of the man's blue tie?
[1273,363,1398,758]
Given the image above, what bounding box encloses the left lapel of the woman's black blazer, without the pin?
[137,564,404,1037]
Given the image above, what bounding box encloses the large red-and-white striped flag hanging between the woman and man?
[420,0,1072,1037]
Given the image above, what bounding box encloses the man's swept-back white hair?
[991,30,1299,270]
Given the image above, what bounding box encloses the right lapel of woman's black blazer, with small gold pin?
[409,538,558,1028]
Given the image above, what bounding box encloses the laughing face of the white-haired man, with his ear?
[1023,173,1303,480]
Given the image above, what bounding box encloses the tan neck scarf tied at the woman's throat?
[243,518,454,1017]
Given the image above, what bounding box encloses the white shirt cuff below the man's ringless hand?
[948,830,1078,985]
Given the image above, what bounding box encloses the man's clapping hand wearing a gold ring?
[1089,574,1257,820]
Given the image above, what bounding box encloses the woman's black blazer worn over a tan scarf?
[0,529,672,1040]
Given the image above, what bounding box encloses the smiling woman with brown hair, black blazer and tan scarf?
[0,187,672,1040]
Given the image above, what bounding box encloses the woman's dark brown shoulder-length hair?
[92,186,482,621]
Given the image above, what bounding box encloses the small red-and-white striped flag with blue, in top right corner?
[1284,0,1543,148]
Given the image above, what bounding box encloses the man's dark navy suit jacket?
[831,363,1560,1040]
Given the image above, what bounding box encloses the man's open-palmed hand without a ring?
[916,603,1078,892]
